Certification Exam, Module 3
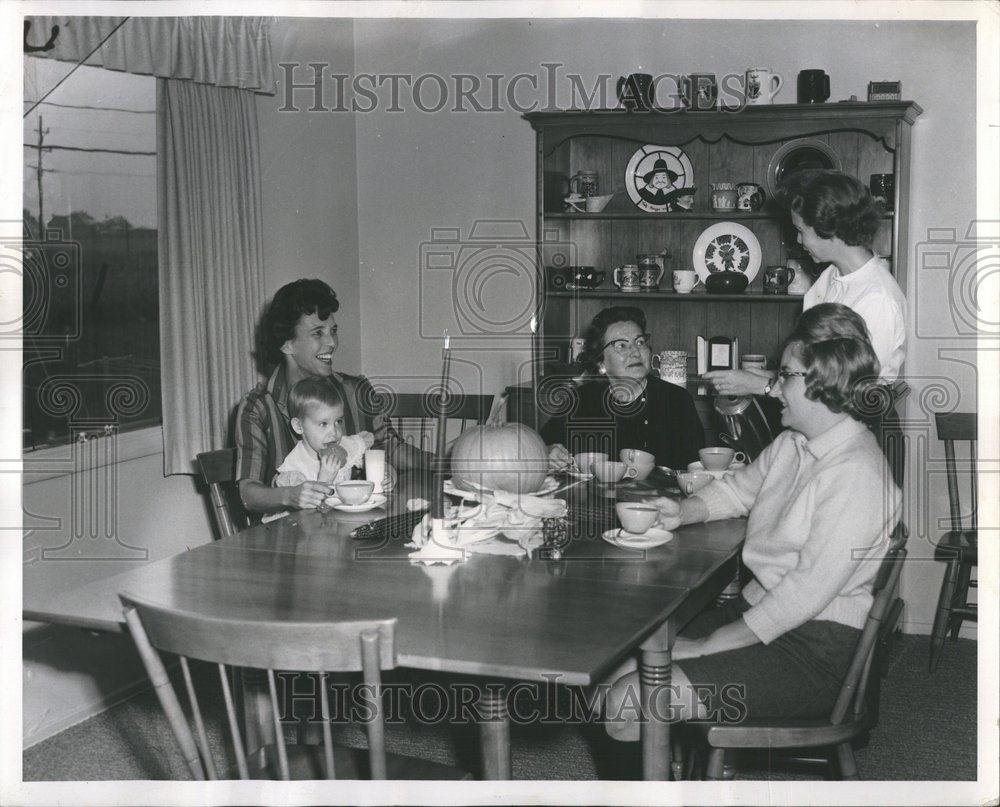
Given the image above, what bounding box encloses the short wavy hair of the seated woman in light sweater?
[784,303,879,420]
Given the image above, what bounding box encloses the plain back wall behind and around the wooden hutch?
[355,20,977,632]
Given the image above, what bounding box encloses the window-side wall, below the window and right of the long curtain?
[22,19,361,746]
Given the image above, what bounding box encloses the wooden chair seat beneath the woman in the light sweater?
[692,710,871,748]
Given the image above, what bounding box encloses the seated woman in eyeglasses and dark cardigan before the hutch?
[542,306,705,469]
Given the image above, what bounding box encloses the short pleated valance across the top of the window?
[25,16,274,94]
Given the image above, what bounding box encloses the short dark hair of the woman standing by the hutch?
[781,170,882,247]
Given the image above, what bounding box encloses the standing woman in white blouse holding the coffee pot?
[705,171,906,395]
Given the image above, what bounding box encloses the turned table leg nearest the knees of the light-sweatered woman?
[639,626,674,781]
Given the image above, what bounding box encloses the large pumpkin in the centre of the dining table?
[451,423,549,493]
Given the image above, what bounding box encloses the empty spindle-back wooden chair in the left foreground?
[121,594,470,781]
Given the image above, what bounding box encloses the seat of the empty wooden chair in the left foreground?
[245,744,472,781]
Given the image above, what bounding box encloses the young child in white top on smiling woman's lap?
[272,378,375,502]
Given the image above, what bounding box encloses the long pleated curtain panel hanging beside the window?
[156,79,264,475]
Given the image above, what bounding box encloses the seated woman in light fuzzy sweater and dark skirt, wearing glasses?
[605,303,902,740]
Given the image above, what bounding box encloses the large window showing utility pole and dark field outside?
[21,57,161,449]
